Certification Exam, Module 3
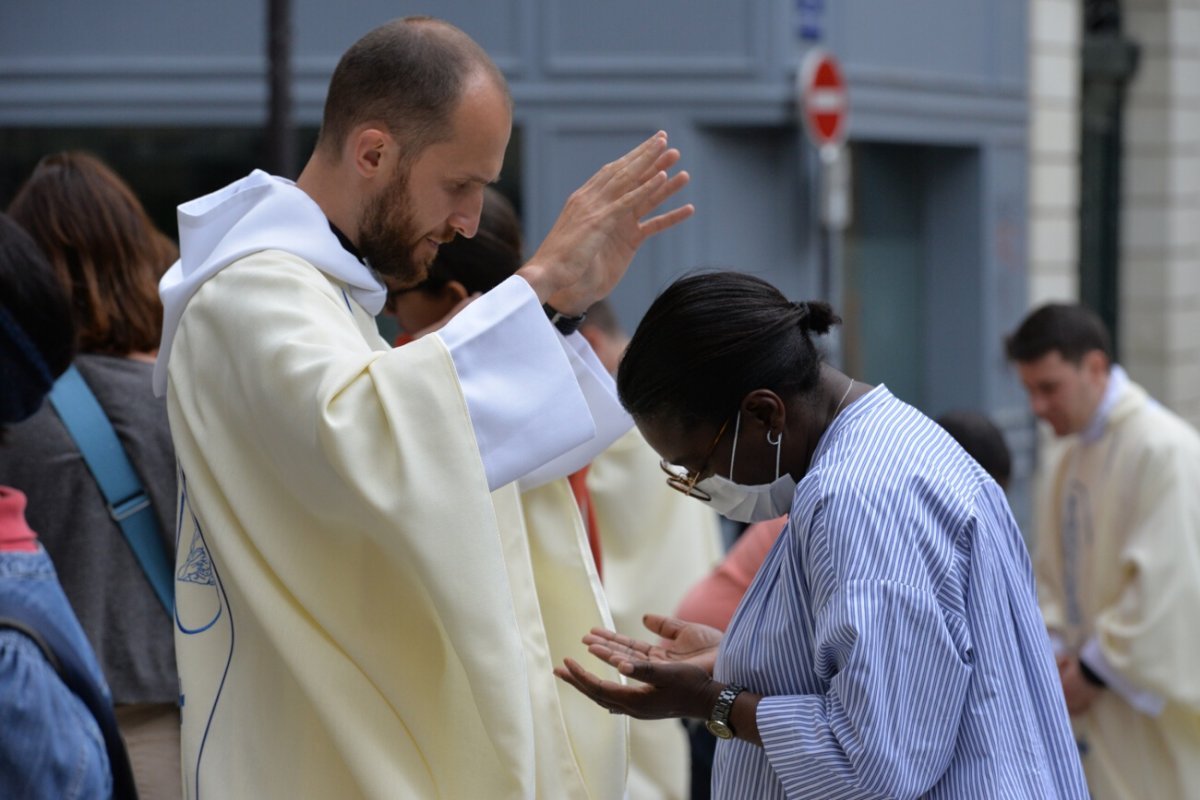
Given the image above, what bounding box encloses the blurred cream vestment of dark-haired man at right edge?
[1034,383,1200,800]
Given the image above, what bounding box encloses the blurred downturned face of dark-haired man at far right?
[1016,350,1109,437]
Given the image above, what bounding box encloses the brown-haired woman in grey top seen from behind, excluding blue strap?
[0,152,181,798]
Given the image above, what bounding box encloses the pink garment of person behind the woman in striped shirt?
[676,517,787,631]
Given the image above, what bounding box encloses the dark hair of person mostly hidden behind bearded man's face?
[413,186,522,294]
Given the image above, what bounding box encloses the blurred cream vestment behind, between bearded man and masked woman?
[587,428,721,800]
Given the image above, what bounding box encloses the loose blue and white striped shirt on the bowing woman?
[713,386,1087,800]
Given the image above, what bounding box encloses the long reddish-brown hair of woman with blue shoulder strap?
[8,152,179,356]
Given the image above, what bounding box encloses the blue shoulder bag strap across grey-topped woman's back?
[50,365,174,616]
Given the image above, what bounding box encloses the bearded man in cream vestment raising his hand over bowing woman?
[156,18,691,799]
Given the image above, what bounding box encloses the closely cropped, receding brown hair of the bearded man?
[317,17,508,157]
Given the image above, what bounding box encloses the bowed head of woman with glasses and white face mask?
[618,272,854,522]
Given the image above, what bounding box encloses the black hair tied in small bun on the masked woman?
[617,272,841,427]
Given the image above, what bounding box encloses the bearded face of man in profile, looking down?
[359,74,512,287]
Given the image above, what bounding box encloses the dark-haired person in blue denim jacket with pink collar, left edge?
[0,213,137,800]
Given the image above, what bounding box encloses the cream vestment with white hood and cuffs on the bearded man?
[164,173,628,800]
